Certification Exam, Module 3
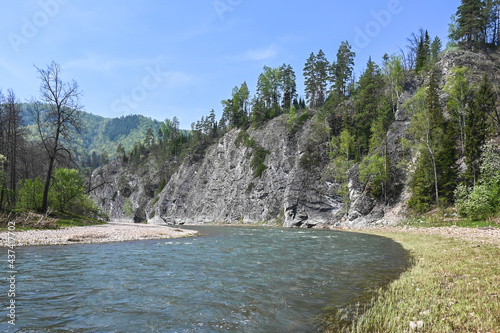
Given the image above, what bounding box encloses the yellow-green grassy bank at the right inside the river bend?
[321,230,500,332]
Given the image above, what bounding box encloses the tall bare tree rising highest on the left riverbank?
[31,62,83,212]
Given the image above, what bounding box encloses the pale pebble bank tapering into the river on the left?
[0,222,198,247]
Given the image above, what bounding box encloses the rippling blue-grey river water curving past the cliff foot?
[0,226,407,332]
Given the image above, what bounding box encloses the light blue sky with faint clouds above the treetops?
[0,0,460,129]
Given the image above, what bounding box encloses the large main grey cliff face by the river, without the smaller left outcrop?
[152,117,342,227]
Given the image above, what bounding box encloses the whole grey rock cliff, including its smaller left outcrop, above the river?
[91,116,344,227]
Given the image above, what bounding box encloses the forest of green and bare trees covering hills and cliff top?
[0,0,500,224]
